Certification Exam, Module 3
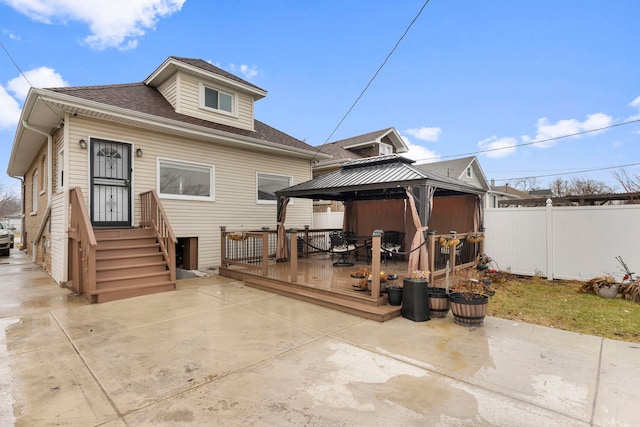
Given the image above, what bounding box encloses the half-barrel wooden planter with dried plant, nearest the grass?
[449,270,495,326]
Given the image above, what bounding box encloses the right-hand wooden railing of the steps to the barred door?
[140,190,178,281]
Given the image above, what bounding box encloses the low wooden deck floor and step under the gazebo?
[220,255,407,322]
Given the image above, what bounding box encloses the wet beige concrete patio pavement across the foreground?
[0,250,640,426]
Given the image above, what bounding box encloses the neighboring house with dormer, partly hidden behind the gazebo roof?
[313,128,409,212]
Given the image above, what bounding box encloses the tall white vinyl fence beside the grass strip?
[484,203,640,281]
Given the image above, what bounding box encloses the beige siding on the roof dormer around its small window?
[176,73,253,130]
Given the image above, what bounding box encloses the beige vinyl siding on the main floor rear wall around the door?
[69,118,312,269]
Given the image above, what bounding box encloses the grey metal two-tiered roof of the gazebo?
[276,154,484,201]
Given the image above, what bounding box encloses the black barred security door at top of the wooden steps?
[91,138,131,227]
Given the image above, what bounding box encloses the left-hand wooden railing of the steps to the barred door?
[69,187,97,295]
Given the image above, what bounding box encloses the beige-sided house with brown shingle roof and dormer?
[8,57,328,300]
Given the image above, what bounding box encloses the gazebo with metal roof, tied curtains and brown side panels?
[276,154,484,272]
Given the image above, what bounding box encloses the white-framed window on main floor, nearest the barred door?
[158,159,215,200]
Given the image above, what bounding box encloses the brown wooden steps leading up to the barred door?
[90,228,176,303]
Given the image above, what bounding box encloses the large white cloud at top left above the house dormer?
[6,0,186,50]
